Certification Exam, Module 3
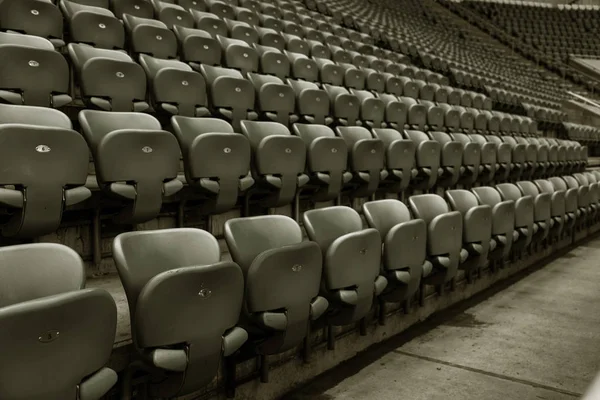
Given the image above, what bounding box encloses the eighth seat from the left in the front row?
[471,186,525,267]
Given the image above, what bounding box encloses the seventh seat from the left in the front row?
[446,189,497,281]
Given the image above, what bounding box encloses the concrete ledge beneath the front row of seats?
[96,224,600,400]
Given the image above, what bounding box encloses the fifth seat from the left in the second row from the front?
[293,124,352,201]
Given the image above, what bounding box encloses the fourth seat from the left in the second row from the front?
[241,120,309,207]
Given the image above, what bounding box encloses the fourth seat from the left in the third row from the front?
[201,65,258,132]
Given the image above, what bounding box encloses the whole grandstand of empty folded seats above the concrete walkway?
[0,0,600,400]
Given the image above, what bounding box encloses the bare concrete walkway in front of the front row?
[285,239,600,400]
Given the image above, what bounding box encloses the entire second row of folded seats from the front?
[0,105,587,237]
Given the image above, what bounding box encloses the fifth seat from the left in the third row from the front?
[248,73,298,125]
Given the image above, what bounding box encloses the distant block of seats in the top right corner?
[456,1,600,90]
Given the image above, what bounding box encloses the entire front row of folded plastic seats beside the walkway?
[5,171,600,400]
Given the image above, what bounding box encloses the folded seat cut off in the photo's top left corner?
[0,0,65,47]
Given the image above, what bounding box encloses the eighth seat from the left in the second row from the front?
[405,130,441,190]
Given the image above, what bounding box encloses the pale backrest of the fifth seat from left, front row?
[362,199,411,241]
